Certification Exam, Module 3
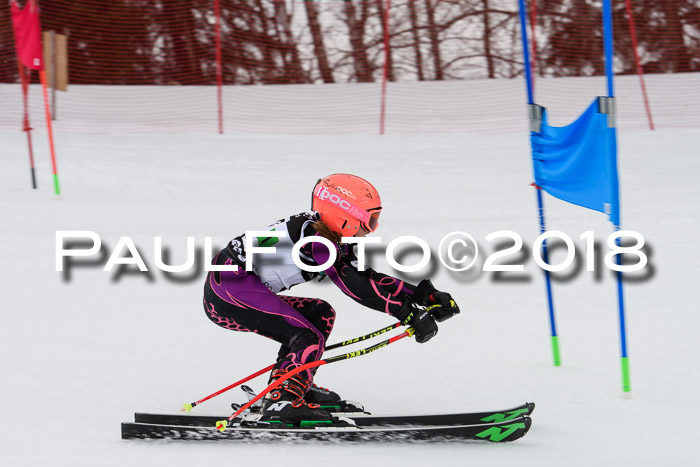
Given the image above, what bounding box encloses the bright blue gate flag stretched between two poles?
[530,98,620,226]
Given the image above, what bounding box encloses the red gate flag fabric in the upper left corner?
[11,0,44,70]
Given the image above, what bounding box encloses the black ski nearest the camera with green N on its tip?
[122,416,532,442]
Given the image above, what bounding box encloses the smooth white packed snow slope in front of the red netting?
[0,75,700,467]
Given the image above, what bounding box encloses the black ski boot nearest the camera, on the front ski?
[258,370,337,426]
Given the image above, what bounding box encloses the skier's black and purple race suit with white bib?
[204,212,415,384]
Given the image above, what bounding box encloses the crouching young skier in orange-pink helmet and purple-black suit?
[204,174,459,424]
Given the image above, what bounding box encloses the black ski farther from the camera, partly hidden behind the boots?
[134,402,535,427]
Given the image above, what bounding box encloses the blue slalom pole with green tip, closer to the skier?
[518,0,561,366]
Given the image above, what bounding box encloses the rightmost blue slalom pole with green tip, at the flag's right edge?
[603,0,631,392]
